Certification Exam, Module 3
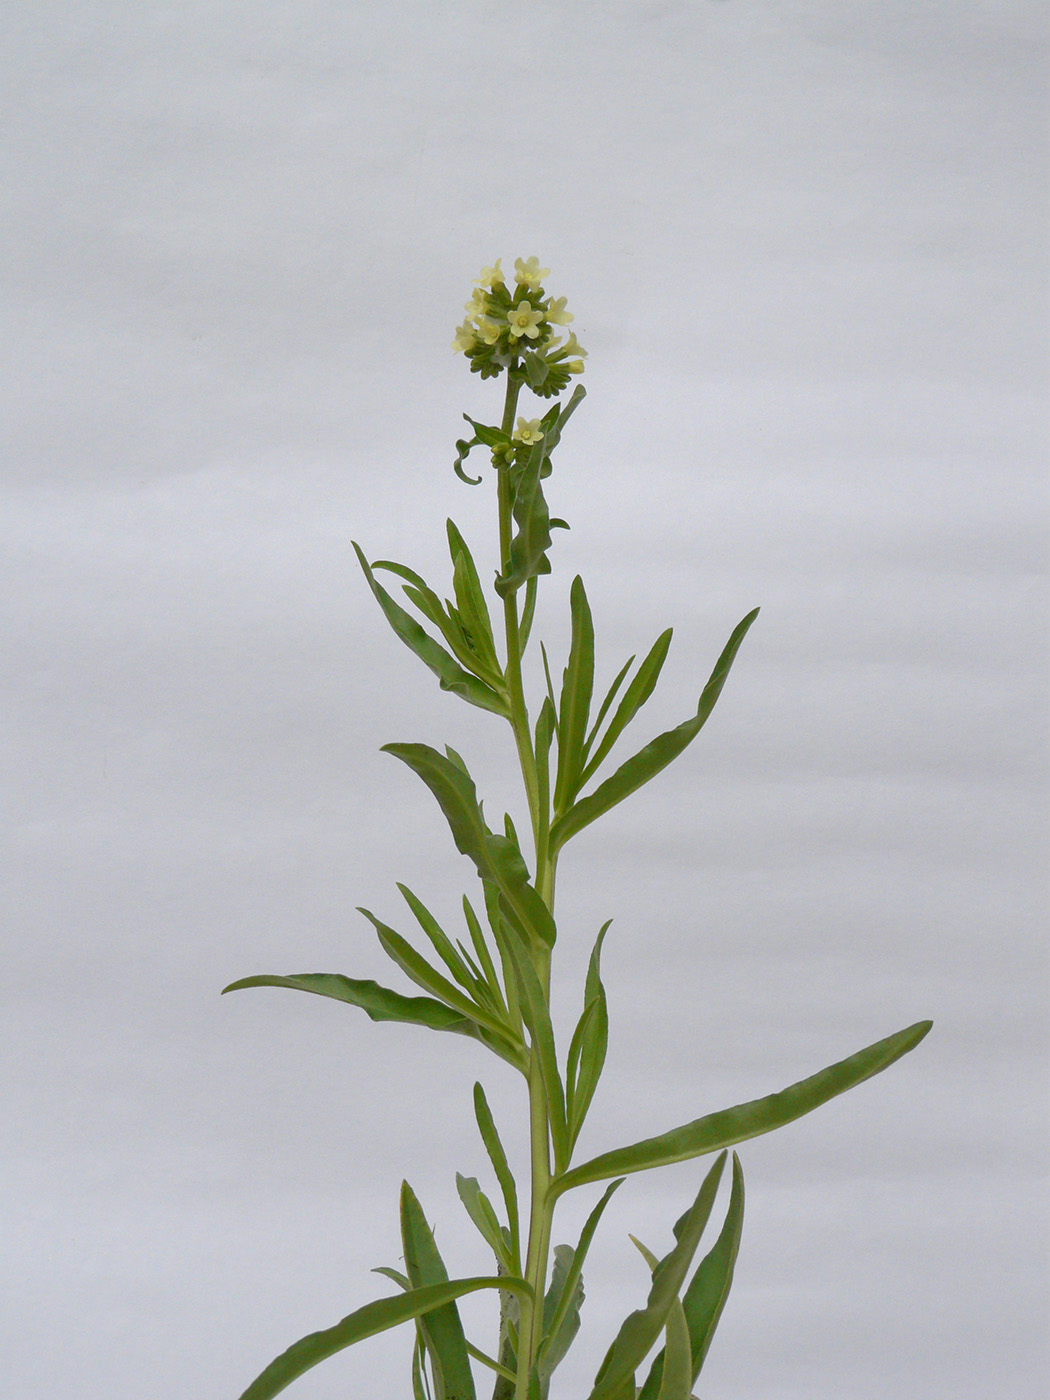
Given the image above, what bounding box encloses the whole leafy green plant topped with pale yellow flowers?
[225,258,931,1400]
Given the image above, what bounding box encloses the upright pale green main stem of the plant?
[498,372,554,1400]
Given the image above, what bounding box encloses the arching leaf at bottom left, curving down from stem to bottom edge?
[233,1275,532,1400]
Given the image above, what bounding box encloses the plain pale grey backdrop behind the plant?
[0,0,1047,1400]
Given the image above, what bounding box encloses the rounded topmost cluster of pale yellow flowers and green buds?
[452,258,587,399]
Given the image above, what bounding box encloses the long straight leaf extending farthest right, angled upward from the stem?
[550,1021,932,1196]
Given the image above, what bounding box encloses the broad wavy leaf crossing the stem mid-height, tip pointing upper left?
[382,743,556,945]
